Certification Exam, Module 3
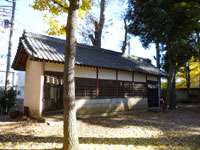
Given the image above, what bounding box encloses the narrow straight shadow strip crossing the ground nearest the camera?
[0,134,200,148]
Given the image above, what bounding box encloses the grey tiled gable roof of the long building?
[12,32,165,76]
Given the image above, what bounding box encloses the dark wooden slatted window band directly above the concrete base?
[75,78,146,98]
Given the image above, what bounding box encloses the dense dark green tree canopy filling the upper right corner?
[127,0,200,75]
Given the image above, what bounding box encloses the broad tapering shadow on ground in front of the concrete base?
[80,106,200,131]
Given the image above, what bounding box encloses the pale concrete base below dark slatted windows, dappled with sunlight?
[76,97,148,116]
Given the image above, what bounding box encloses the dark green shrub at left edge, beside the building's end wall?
[0,88,16,114]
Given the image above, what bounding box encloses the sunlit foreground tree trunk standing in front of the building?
[63,0,79,150]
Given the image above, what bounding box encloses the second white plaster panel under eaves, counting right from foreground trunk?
[99,69,116,80]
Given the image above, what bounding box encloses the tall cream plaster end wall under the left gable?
[24,60,44,117]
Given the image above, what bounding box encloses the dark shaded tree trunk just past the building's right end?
[167,49,176,109]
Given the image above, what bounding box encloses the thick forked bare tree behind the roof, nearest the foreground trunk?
[80,0,116,48]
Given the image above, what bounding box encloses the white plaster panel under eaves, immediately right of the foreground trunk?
[75,66,97,78]
